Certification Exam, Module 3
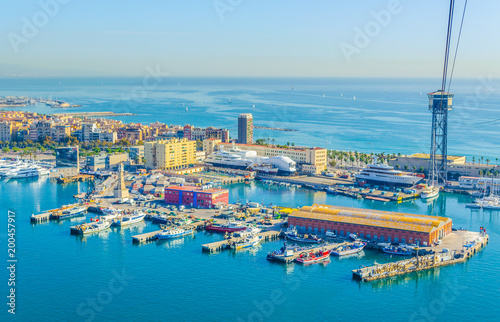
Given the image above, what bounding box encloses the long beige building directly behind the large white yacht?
[217,143,327,174]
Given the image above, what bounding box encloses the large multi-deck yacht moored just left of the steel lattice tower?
[354,156,423,186]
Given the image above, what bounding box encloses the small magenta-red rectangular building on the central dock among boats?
[165,186,229,208]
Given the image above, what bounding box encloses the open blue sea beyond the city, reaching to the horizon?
[0,77,500,158]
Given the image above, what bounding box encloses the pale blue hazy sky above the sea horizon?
[0,0,500,77]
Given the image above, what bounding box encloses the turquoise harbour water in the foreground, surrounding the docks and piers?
[0,180,500,321]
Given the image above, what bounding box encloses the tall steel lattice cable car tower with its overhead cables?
[427,0,467,185]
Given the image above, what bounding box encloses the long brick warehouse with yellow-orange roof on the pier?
[288,204,452,246]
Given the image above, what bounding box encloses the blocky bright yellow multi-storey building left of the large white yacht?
[144,139,196,170]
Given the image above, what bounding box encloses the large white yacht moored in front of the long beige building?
[205,146,297,175]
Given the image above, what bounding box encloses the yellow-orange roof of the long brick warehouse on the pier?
[289,204,451,233]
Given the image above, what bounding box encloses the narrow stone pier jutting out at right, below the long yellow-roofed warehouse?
[352,234,489,282]
